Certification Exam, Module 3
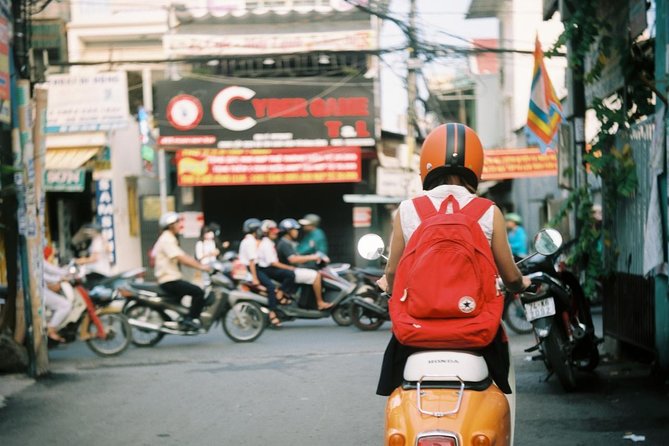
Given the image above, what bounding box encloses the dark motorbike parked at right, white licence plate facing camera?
[521,230,601,391]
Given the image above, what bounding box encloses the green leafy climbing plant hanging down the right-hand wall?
[546,0,657,296]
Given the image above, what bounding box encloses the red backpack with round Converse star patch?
[389,195,504,349]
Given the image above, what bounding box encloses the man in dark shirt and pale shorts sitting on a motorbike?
[276,218,332,311]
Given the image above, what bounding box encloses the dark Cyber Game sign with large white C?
[156,77,375,149]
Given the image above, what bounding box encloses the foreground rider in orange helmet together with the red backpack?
[377,123,530,396]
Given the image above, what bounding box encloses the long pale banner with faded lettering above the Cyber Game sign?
[164,30,376,57]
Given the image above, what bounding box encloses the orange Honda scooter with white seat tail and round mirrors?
[358,230,561,446]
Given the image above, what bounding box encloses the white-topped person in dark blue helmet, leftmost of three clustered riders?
[239,218,282,328]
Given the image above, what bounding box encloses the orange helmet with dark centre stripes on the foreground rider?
[420,123,483,187]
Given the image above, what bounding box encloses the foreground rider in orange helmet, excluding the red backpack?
[376,123,530,396]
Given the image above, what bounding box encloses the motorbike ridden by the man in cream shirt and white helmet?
[123,262,267,347]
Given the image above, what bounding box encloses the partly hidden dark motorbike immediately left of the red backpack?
[350,268,390,331]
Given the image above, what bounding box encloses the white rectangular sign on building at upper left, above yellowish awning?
[46,71,130,133]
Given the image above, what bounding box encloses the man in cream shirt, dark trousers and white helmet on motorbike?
[153,212,211,330]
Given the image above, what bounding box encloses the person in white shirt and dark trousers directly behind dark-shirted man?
[256,220,295,305]
